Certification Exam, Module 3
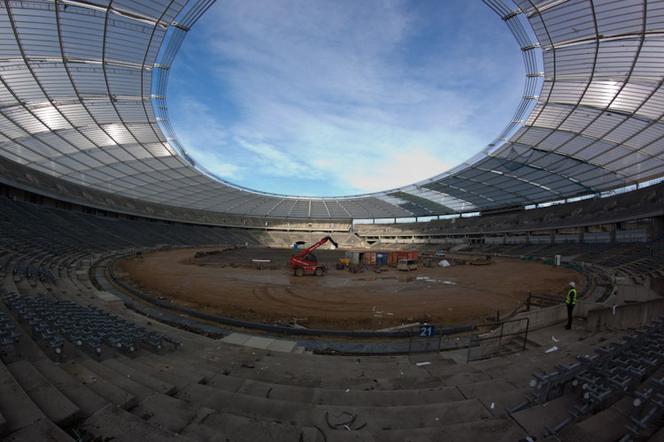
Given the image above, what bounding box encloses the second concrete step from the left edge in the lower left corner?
[7,360,80,427]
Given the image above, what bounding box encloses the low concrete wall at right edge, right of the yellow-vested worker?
[586,299,664,331]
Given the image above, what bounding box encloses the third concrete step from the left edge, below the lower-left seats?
[32,359,109,418]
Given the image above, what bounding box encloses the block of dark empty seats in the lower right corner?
[510,318,664,441]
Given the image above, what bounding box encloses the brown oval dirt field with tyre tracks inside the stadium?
[116,248,583,329]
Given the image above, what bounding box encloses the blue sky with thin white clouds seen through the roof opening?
[168,0,524,196]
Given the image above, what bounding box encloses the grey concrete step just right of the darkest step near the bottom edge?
[131,394,214,433]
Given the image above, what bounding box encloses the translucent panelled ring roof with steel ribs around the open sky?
[0,0,664,219]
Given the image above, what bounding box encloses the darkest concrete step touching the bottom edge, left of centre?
[79,405,197,442]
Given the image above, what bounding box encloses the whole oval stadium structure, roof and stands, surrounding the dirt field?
[0,0,664,442]
